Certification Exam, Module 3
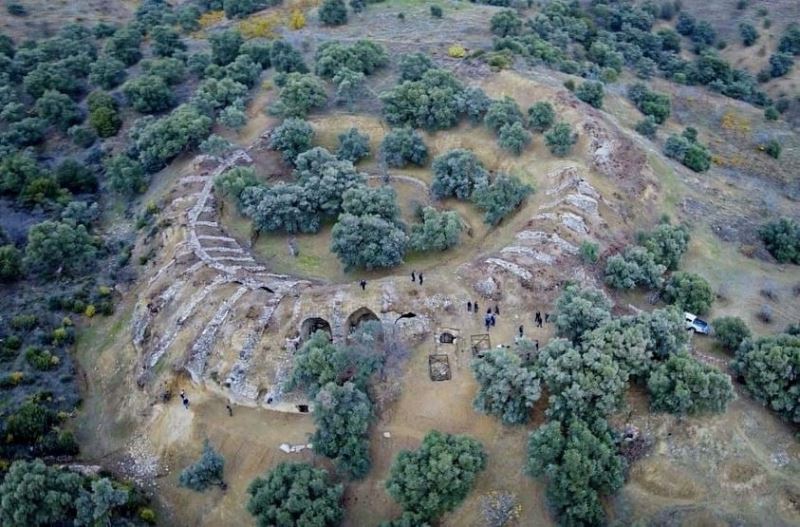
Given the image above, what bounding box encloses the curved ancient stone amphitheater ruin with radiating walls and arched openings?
[132,113,643,411]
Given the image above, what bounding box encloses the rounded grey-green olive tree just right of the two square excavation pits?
[471,348,542,425]
